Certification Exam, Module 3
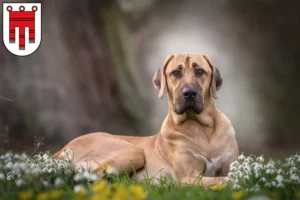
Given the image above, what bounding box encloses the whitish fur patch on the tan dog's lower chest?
[193,152,231,177]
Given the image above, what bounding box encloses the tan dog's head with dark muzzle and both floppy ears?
[153,54,222,114]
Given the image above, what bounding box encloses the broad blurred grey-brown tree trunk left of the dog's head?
[0,0,151,152]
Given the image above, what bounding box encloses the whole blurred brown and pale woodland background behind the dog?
[0,0,300,157]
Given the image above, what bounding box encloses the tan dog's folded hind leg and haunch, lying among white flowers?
[54,134,145,174]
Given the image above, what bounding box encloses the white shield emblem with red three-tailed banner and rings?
[3,3,42,56]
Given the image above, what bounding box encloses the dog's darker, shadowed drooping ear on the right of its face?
[203,55,223,99]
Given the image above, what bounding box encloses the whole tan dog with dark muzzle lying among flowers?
[55,54,239,185]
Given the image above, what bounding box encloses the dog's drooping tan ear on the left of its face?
[152,55,174,99]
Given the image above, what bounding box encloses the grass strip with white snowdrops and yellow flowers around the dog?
[0,152,300,200]
